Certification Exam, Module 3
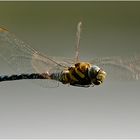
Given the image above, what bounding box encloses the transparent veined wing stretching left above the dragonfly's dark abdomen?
[0,28,72,87]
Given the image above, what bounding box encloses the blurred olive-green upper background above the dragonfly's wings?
[0,1,140,58]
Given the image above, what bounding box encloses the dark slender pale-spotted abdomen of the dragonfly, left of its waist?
[0,73,48,82]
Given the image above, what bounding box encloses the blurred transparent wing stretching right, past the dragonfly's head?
[91,55,140,80]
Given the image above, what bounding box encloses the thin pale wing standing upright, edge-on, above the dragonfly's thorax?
[75,21,82,62]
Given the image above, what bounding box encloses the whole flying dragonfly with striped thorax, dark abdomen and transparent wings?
[0,21,140,87]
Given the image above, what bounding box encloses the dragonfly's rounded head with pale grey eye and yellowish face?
[88,65,107,85]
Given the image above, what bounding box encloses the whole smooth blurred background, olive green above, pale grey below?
[0,1,140,138]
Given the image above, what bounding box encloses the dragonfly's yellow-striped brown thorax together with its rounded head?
[60,62,104,86]
